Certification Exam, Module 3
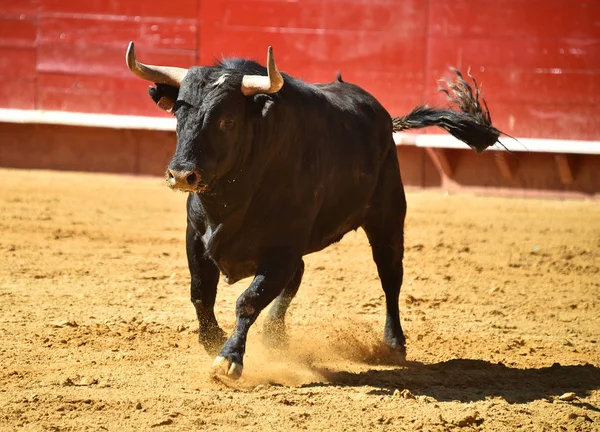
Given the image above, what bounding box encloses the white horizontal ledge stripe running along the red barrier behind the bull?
[0,108,600,154]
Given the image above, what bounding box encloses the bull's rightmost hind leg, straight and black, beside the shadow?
[363,152,406,359]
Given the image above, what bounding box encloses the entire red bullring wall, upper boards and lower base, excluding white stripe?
[0,0,600,196]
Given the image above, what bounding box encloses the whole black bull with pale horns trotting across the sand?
[127,44,500,378]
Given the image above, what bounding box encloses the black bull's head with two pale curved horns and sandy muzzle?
[126,42,283,192]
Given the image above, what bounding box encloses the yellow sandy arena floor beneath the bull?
[0,170,600,432]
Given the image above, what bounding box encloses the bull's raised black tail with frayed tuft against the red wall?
[392,68,501,152]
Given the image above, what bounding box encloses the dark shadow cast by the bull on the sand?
[305,359,600,404]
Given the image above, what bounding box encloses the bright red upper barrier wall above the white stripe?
[0,0,600,140]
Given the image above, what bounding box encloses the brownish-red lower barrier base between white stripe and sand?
[0,119,600,199]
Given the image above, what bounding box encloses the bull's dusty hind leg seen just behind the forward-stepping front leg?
[263,261,304,348]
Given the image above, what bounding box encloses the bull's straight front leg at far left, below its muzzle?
[186,221,226,356]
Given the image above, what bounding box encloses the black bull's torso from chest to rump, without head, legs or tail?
[188,66,404,282]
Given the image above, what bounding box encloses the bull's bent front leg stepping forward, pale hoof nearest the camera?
[213,250,302,379]
